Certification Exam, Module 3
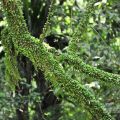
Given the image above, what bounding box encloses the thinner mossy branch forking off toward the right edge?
[60,54,120,86]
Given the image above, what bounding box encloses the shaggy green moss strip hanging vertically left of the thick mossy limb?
[1,28,20,89]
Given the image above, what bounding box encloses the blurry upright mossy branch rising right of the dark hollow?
[69,0,96,53]
